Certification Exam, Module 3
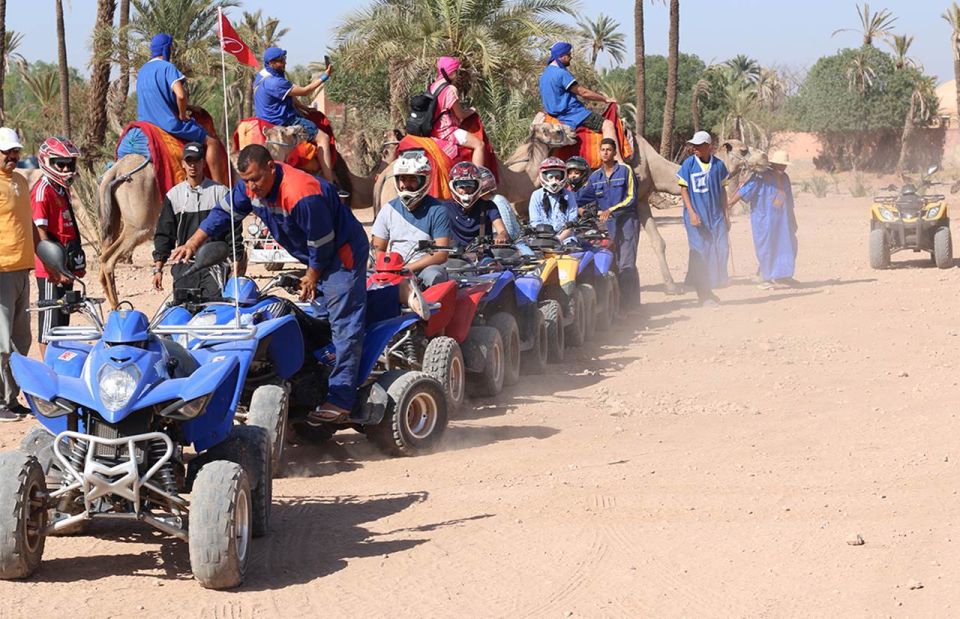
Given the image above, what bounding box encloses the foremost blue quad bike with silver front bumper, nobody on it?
[0,241,284,589]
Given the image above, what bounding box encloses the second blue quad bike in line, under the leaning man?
[154,260,448,458]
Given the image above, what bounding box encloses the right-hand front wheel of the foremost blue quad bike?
[189,460,253,589]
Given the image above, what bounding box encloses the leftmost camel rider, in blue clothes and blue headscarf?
[137,32,227,184]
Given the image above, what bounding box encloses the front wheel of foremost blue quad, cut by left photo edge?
[0,450,47,580]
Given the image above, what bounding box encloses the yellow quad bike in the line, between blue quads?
[524,226,596,362]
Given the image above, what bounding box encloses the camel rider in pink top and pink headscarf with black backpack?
[430,56,486,167]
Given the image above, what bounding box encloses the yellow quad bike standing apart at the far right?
[870,166,953,269]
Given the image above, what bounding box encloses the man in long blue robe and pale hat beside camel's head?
[729,151,797,289]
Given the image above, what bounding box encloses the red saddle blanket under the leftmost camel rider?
[117,108,227,196]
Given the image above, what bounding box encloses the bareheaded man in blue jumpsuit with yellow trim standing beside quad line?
[577,138,640,309]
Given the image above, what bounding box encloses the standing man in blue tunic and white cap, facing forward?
[677,131,730,306]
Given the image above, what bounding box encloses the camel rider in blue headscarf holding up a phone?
[253,47,333,182]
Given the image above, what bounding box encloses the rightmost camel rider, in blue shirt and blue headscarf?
[540,41,620,161]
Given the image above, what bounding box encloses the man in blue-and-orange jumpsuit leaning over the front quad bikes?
[170,144,370,423]
